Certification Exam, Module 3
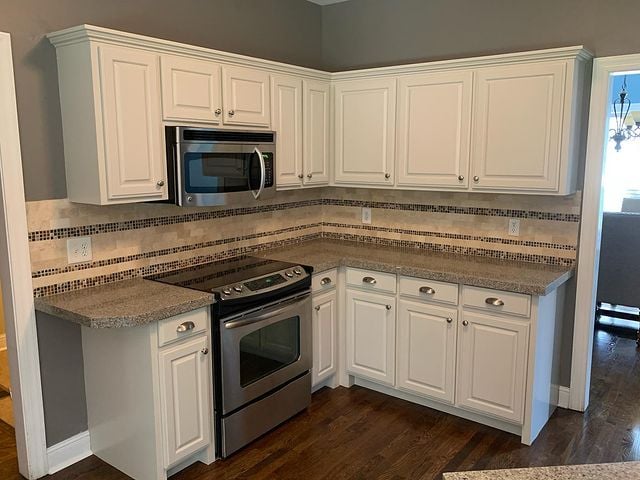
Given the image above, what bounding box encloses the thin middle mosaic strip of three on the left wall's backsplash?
[31,223,321,278]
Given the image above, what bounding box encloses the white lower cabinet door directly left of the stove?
[160,335,212,467]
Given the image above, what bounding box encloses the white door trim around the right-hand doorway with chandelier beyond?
[569,54,640,411]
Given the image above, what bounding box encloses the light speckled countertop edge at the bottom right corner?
[442,462,640,480]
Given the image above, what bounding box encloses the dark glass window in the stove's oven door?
[240,316,300,387]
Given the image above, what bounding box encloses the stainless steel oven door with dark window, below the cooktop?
[219,293,311,415]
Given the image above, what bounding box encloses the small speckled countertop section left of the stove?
[35,278,214,328]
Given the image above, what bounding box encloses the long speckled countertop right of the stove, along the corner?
[257,239,573,295]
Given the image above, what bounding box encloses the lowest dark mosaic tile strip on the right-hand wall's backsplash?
[322,232,575,267]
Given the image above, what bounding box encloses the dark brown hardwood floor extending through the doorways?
[0,330,640,480]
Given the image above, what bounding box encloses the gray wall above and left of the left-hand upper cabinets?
[0,0,321,200]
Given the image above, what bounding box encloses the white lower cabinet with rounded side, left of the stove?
[82,307,215,480]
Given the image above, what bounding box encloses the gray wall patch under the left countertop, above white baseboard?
[36,312,87,447]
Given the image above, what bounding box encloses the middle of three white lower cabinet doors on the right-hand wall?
[398,300,458,403]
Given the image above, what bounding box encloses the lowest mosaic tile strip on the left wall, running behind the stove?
[33,233,321,298]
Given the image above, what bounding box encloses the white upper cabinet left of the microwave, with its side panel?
[52,41,167,205]
